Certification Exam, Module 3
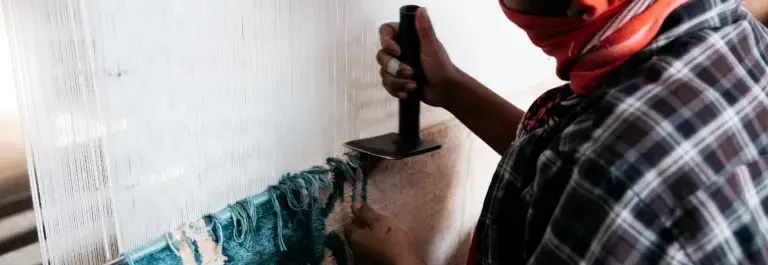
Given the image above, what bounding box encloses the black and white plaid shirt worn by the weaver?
[474,0,768,264]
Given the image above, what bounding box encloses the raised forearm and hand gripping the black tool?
[376,8,523,154]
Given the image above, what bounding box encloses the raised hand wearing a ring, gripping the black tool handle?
[376,7,461,107]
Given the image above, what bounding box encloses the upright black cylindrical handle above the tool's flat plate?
[395,5,426,147]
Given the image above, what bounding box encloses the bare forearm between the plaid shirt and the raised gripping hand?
[443,70,524,154]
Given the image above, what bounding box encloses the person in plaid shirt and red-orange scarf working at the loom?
[346,0,768,265]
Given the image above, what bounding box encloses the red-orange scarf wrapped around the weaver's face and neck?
[499,0,688,94]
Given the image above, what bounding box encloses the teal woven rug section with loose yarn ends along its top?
[122,154,367,265]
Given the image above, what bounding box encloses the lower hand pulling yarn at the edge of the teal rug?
[345,204,424,265]
